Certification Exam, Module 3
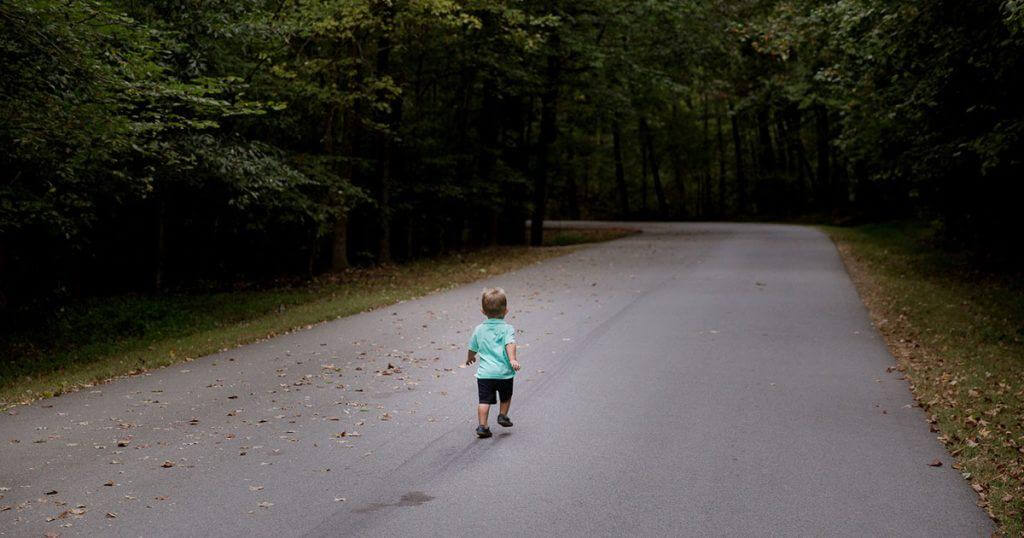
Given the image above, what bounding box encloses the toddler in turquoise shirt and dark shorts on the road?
[466,288,519,438]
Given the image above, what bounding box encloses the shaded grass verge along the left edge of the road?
[0,225,634,409]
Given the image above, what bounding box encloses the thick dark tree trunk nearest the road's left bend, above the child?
[529,49,561,247]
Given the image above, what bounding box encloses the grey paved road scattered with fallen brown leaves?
[0,223,992,536]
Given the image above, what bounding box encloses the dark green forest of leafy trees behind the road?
[0,0,1024,307]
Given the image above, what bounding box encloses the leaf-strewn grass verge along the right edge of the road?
[824,222,1024,536]
